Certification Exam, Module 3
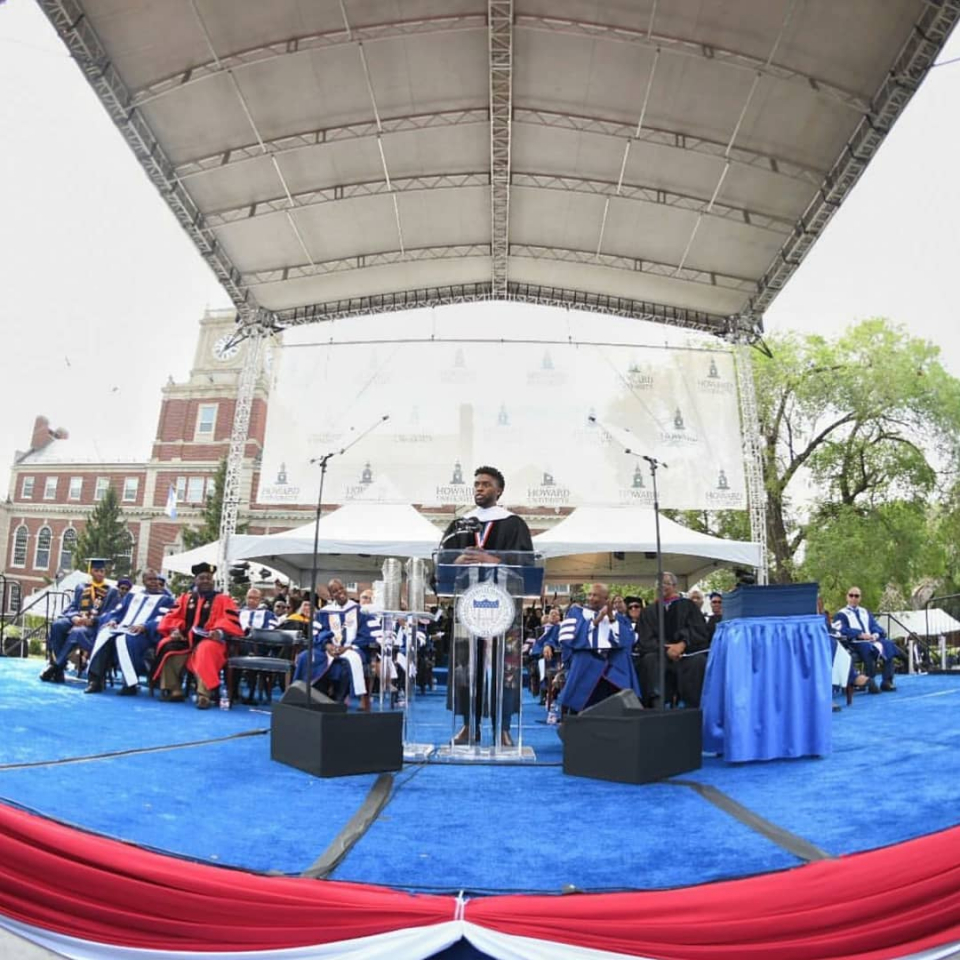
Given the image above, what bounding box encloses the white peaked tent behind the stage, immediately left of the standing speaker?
[230,503,441,584]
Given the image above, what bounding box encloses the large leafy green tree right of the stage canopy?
[754,319,960,590]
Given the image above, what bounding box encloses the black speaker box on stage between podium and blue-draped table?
[562,697,703,783]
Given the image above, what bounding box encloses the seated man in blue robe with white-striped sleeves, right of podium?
[543,583,640,713]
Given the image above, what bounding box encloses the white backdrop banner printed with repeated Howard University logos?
[258,340,746,510]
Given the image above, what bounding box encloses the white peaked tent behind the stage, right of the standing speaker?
[533,507,760,585]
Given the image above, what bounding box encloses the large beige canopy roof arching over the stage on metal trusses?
[38,0,958,334]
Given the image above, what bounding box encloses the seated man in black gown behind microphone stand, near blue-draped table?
[637,571,710,707]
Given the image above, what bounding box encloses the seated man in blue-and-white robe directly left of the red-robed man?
[83,570,174,697]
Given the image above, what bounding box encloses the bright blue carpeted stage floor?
[0,659,960,893]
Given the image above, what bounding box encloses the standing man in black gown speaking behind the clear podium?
[440,466,533,746]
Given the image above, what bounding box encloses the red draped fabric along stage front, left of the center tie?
[0,805,456,951]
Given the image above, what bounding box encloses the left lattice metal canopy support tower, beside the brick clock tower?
[216,311,273,591]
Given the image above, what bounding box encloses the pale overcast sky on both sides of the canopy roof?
[0,0,960,474]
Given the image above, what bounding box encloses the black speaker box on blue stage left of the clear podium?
[270,697,403,777]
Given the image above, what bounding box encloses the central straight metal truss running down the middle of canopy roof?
[487,0,513,296]
